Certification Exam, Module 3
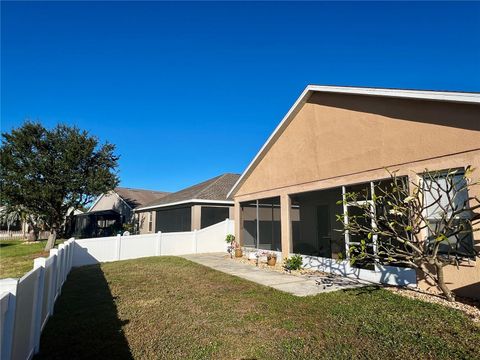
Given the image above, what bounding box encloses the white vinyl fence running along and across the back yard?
[0,219,234,360]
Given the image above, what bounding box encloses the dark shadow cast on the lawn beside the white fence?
[35,265,133,360]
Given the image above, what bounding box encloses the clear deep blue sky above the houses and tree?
[1,2,480,191]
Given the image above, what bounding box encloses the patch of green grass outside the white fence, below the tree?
[0,240,63,279]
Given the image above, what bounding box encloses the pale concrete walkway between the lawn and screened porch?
[182,253,365,296]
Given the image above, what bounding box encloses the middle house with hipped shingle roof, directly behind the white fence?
[135,174,240,234]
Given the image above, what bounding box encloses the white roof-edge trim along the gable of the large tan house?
[227,85,480,198]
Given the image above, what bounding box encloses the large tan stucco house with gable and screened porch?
[229,86,480,297]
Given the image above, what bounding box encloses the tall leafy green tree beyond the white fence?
[0,121,119,250]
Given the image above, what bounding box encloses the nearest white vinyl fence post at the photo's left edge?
[0,278,18,360]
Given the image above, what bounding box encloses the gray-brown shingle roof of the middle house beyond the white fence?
[140,174,240,207]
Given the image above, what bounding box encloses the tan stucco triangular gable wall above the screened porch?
[236,94,480,196]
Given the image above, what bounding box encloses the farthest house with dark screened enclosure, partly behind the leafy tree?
[72,187,168,238]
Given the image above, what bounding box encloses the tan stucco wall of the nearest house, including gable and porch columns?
[234,94,480,297]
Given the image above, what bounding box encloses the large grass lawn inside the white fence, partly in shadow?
[38,257,480,359]
